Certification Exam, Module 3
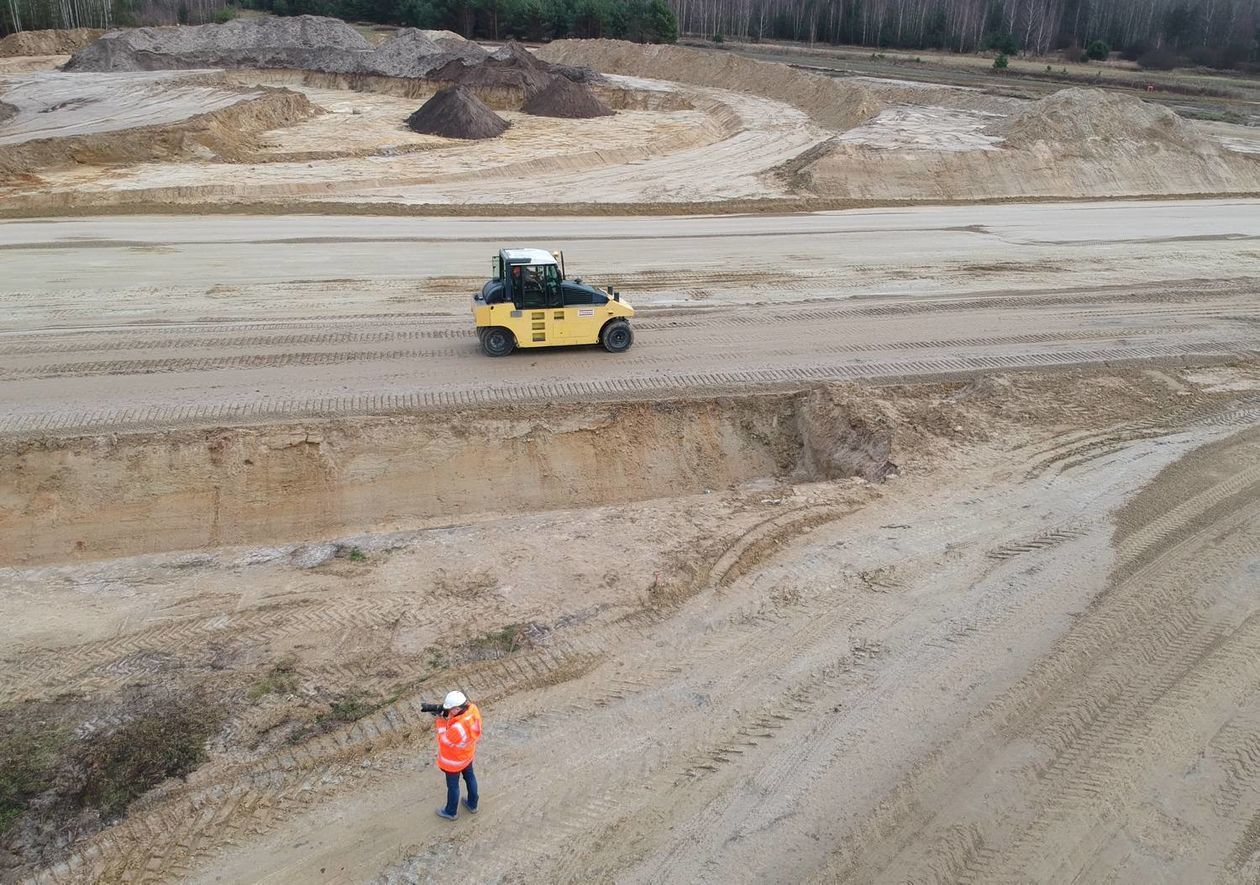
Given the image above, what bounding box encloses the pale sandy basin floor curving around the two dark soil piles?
[0,74,827,204]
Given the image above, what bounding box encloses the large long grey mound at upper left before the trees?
[64,15,372,73]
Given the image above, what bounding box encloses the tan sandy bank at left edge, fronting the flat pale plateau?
[0,90,321,180]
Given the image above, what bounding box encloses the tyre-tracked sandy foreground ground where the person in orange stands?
[0,364,1260,882]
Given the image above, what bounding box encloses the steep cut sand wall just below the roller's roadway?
[0,392,891,565]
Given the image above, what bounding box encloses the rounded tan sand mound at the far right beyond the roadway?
[1003,88,1215,153]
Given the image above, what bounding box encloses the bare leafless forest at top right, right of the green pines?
[673,0,1260,61]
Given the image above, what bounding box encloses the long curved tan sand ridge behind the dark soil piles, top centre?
[538,40,882,130]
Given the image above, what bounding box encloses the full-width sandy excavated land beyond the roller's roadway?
[9,40,1260,213]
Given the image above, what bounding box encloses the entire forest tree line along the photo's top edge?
[0,0,1260,67]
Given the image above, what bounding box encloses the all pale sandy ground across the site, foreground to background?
[7,31,1260,884]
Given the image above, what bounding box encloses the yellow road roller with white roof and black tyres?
[473,248,634,357]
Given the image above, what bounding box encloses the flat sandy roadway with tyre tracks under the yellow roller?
[0,200,1260,434]
